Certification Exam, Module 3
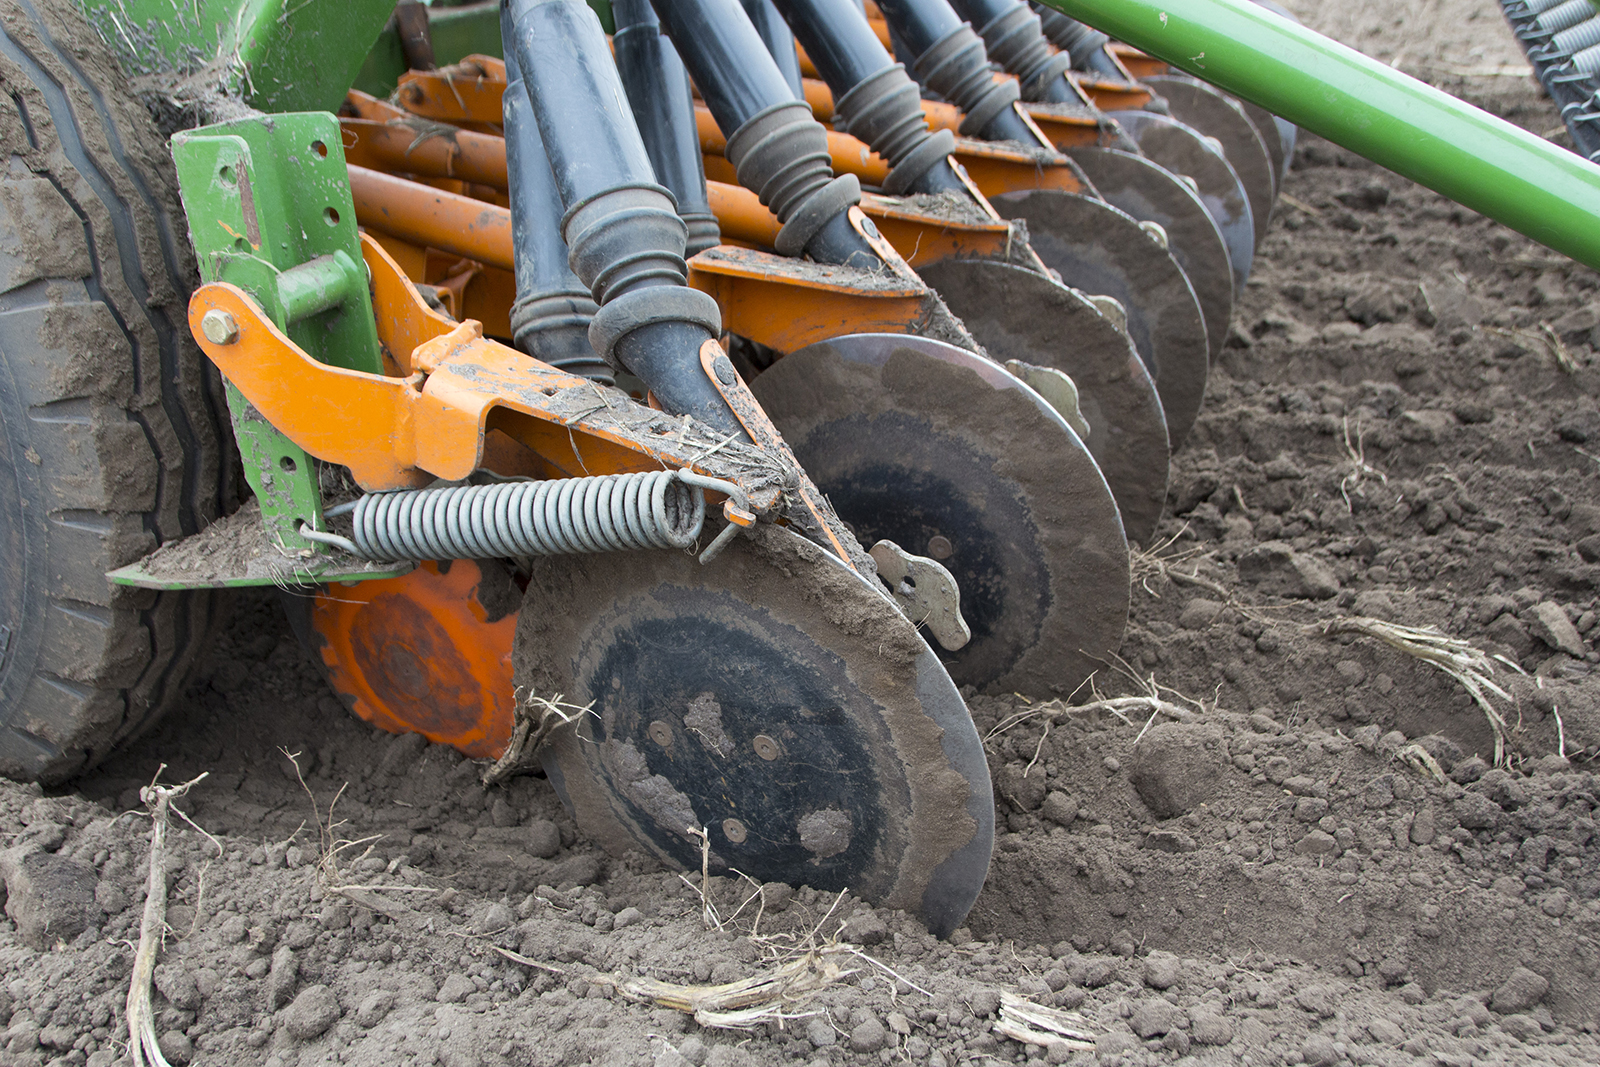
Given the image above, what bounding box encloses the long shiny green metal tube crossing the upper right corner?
[1040,0,1600,269]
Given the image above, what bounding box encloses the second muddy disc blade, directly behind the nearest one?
[752,334,1138,694]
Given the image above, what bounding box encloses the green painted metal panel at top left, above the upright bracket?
[78,0,395,112]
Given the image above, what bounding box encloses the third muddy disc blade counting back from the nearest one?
[921,259,1171,543]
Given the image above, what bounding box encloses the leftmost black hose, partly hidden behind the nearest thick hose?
[502,14,613,382]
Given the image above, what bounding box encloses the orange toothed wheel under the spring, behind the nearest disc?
[310,560,520,758]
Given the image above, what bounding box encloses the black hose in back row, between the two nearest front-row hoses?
[611,0,720,256]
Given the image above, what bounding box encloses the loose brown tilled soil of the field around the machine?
[0,0,1600,1067]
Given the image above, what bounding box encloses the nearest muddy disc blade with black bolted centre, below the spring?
[515,525,994,936]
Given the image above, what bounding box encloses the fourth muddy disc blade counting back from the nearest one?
[992,189,1211,451]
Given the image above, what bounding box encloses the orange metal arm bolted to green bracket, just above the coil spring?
[189,235,776,510]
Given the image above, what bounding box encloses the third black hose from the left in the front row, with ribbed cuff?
[778,0,970,197]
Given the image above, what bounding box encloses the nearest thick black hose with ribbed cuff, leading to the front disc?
[502,0,749,440]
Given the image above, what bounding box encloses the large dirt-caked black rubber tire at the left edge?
[0,0,237,782]
